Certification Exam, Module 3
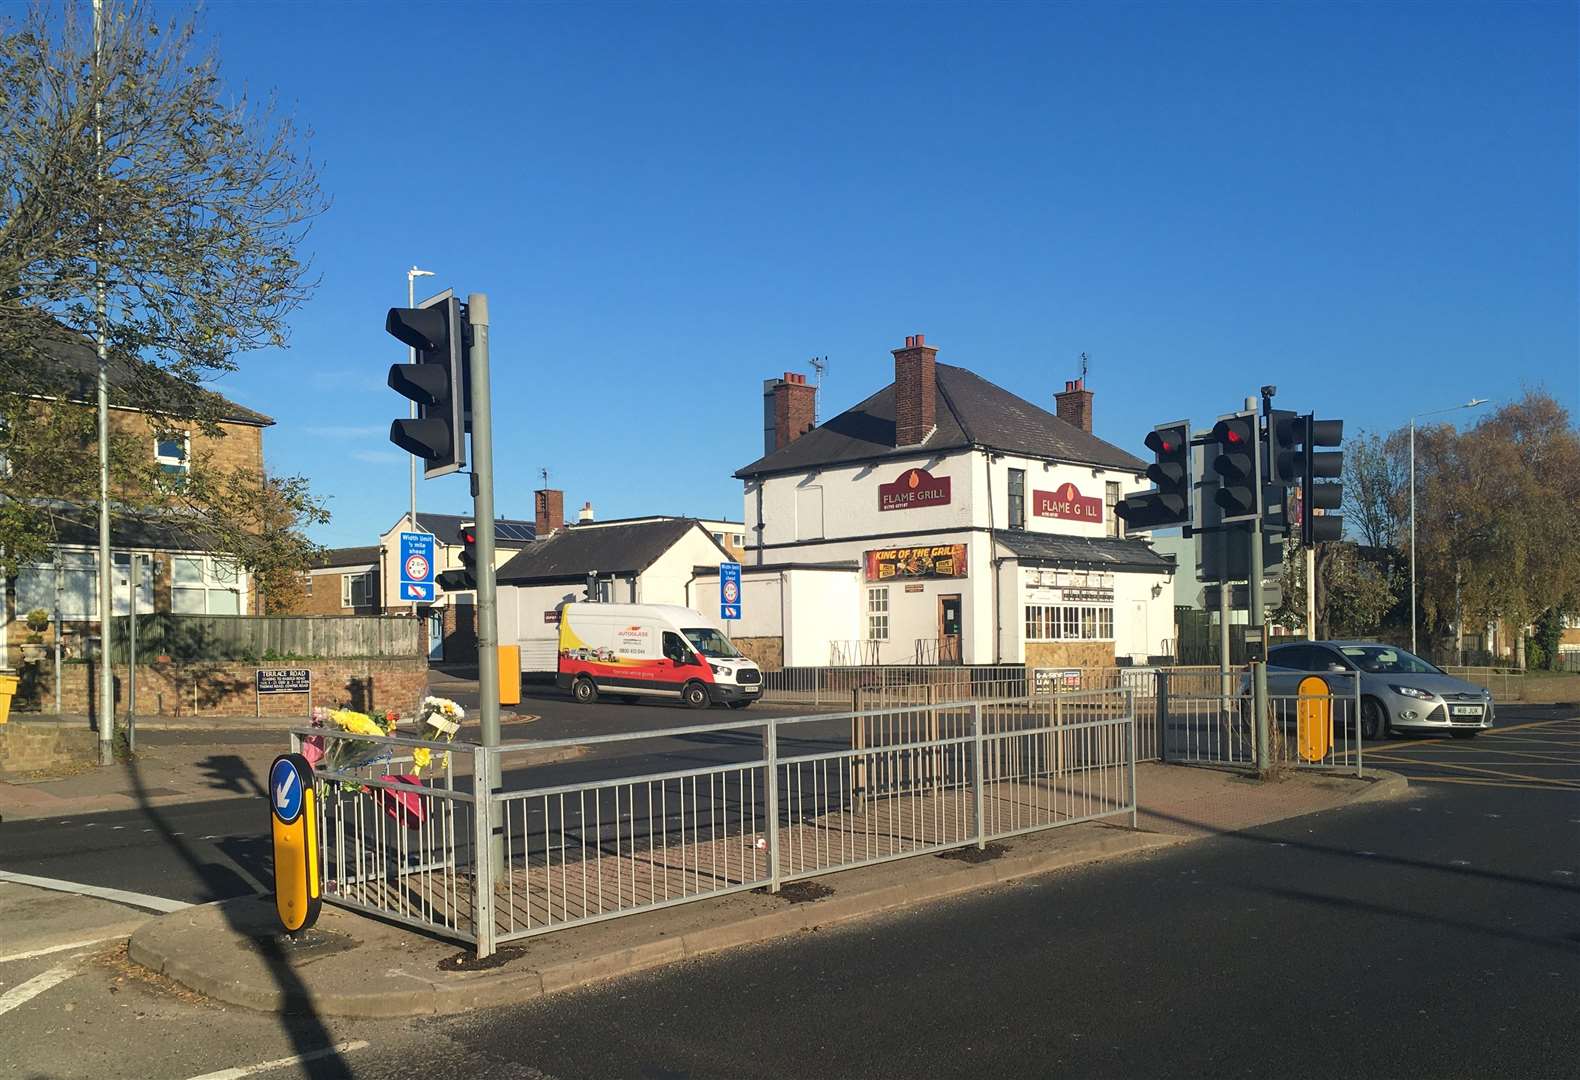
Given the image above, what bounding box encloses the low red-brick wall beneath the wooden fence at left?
[16,660,428,717]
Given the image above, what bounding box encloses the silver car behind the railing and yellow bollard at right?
[1267,641,1493,739]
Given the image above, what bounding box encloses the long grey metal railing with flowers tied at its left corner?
[294,688,1136,955]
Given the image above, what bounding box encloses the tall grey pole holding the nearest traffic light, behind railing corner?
[466,292,504,868]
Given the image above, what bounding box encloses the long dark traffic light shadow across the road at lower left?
[130,755,351,1080]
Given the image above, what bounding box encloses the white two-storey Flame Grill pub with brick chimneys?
[711,335,1174,668]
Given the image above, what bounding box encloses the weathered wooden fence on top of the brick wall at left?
[111,613,423,663]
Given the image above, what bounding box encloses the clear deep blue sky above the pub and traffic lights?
[191,3,1580,545]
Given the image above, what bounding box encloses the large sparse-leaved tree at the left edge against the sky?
[0,2,325,576]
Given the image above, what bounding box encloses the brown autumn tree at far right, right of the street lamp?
[1416,390,1580,666]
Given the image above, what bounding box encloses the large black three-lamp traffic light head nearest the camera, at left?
[384,291,469,480]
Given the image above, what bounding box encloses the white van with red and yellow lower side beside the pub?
[555,602,763,709]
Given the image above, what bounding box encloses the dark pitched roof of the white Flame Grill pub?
[735,363,1147,480]
